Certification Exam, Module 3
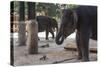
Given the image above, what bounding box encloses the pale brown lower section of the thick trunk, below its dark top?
[27,20,38,54]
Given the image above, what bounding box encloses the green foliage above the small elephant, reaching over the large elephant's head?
[36,3,77,18]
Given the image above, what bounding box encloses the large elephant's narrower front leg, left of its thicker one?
[76,31,82,59]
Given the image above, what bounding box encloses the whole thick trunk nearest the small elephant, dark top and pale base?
[27,2,38,54]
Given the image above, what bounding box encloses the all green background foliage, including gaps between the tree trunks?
[14,1,78,18]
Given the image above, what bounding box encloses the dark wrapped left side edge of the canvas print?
[10,1,14,66]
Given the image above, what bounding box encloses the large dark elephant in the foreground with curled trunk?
[55,5,97,61]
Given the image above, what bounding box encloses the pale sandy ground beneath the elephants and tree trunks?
[14,33,97,66]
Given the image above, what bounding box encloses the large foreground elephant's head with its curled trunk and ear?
[55,9,78,45]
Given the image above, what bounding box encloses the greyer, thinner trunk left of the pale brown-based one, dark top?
[18,1,26,46]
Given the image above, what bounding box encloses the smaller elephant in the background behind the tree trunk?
[36,16,58,40]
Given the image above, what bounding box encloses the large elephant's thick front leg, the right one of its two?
[80,28,90,61]
